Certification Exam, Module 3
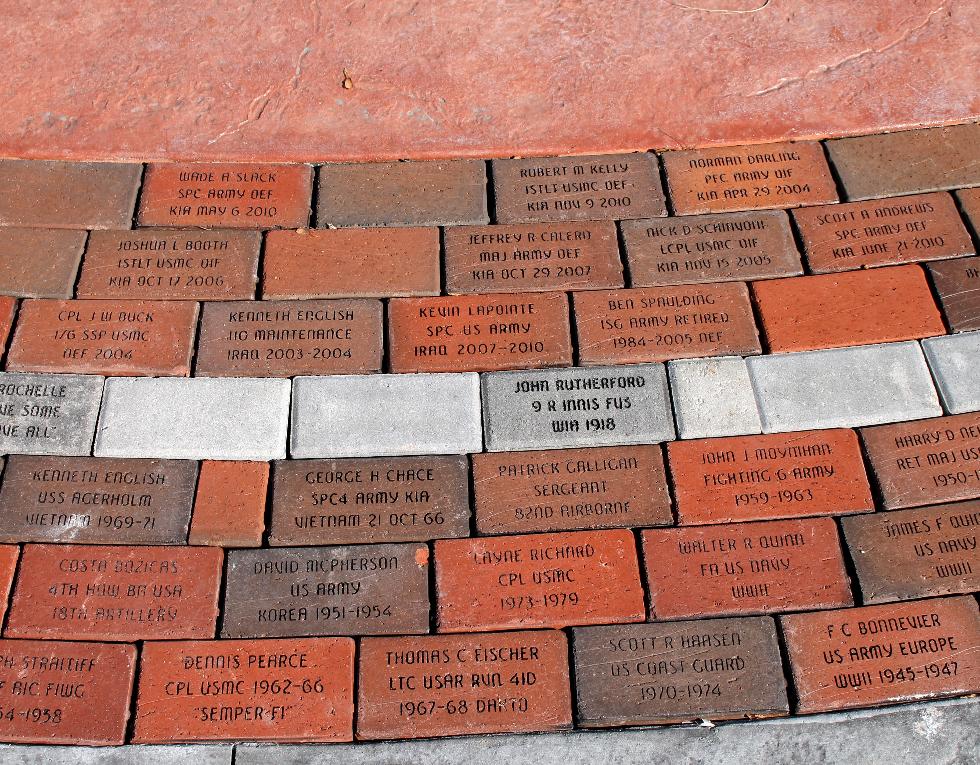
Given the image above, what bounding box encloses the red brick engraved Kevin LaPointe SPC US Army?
[388,292,572,372]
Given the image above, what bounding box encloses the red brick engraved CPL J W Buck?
[7,300,197,375]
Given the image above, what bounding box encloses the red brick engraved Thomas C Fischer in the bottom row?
[357,630,572,740]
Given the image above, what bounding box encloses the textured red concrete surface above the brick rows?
[0,0,980,161]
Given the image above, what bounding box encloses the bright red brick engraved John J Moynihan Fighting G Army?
[667,430,874,525]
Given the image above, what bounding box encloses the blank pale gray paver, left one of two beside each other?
[95,377,289,460]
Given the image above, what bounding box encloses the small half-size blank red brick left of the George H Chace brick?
[187,460,269,547]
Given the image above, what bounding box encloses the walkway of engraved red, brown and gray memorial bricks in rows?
[0,124,980,752]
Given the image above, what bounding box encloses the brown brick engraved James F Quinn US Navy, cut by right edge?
[841,500,980,603]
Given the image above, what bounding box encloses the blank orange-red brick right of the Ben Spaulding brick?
[752,266,946,353]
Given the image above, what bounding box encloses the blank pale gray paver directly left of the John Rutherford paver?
[290,372,483,458]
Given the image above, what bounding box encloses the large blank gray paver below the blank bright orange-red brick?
[746,342,942,433]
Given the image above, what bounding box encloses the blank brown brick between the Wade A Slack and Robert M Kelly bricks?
[316,159,489,228]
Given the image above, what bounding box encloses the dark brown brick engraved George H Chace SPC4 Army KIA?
[269,456,470,546]
